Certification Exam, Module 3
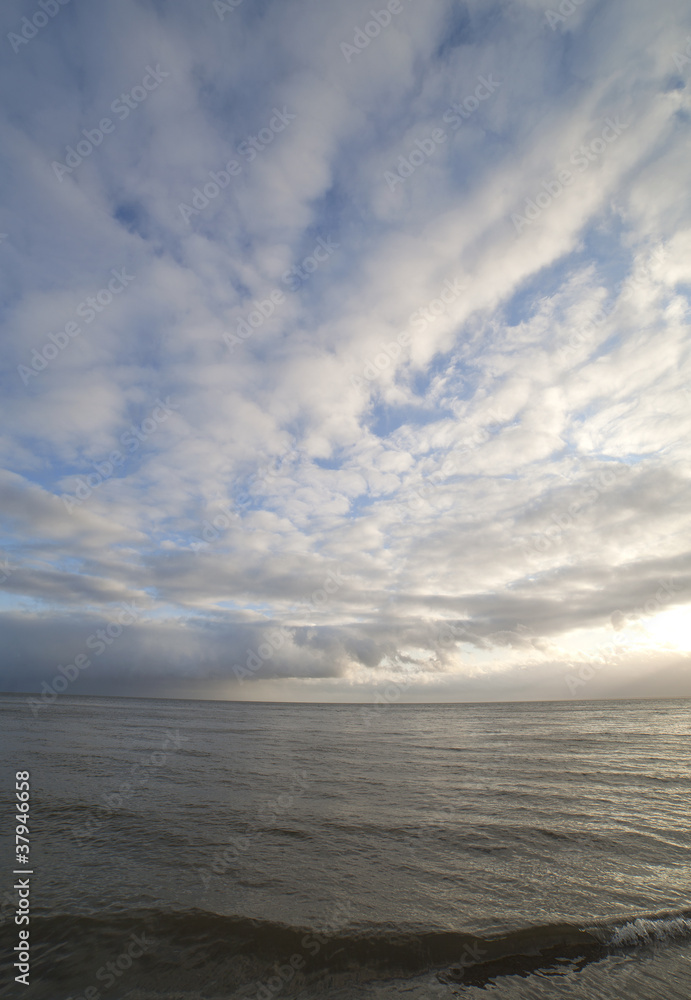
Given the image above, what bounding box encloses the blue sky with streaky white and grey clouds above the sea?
[0,0,691,714]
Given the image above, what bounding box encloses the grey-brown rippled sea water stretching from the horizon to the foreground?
[0,695,691,1000]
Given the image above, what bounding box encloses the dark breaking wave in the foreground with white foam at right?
[5,908,691,994]
